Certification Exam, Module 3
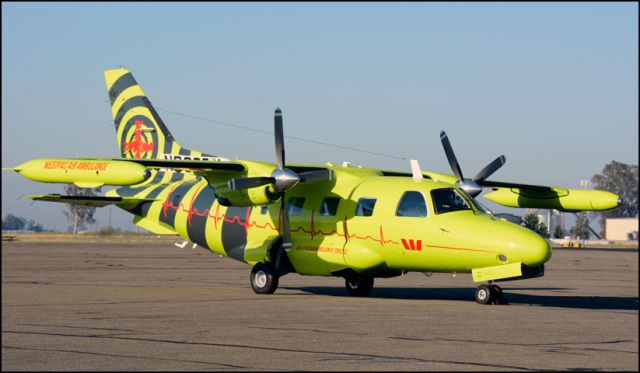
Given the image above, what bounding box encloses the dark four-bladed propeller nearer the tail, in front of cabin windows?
[228,108,333,258]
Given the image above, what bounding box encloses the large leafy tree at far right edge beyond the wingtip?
[591,161,638,233]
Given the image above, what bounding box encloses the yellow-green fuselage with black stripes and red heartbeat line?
[107,161,551,276]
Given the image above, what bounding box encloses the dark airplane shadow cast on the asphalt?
[288,286,638,311]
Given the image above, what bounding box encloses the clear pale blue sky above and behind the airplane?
[2,2,638,229]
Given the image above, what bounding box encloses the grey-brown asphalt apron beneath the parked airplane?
[1,239,638,371]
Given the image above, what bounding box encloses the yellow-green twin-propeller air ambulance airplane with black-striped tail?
[7,68,620,304]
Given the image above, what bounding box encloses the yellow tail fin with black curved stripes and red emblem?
[104,68,221,160]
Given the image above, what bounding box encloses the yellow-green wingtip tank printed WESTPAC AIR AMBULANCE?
[8,158,151,188]
